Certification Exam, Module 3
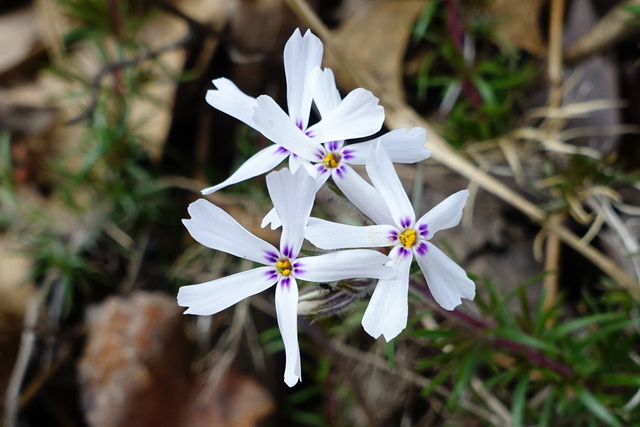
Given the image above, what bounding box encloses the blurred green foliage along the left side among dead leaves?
[0,0,180,320]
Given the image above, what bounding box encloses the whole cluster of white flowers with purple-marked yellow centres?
[178,30,475,386]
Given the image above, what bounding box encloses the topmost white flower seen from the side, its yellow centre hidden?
[202,30,384,194]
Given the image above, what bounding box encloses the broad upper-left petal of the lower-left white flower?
[182,199,278,264]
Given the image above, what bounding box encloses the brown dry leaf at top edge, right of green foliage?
[487,0,547,56]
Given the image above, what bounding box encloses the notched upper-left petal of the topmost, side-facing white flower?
[205,78,258,128]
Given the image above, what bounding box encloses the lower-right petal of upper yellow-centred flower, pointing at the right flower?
[332,165,393,224]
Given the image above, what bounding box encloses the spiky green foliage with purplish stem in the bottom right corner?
[409,277,640,426]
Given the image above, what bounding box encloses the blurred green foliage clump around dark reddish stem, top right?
[413,1,536,147]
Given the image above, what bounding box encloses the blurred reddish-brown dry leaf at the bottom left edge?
[79,292,274,427]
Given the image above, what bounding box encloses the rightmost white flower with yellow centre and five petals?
[305,142,475,341]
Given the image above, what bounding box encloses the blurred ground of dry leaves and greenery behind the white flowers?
[0,0,640,427]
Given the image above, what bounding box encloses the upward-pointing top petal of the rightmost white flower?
[366,141,416,228]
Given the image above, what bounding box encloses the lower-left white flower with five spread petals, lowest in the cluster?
[178,169,393,386]
